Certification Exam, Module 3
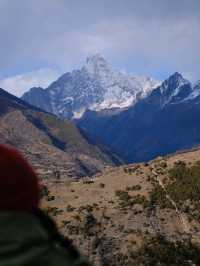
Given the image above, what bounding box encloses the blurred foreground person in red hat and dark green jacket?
[0,145,89,266]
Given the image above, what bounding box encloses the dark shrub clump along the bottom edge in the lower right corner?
[129,236,200,266]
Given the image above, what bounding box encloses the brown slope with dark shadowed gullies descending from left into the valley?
[0,90,119,178]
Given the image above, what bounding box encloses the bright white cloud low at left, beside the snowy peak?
[0,68,59,97]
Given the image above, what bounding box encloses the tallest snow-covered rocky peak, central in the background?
[22,54,159,119]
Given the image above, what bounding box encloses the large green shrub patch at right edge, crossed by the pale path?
[150,161,200,221]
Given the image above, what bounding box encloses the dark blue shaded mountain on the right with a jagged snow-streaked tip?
[78,73,200,162]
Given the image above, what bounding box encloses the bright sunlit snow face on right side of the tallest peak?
[80,54,160,111]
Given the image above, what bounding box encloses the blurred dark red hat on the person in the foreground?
[0,145,39,211]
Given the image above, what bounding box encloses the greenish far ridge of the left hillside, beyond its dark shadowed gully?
[27,109,120,165]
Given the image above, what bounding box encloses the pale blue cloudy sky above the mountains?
[0,0,200,96]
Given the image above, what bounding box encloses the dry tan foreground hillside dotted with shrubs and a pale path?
[42,149,200,266]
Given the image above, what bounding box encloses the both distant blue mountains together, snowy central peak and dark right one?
[22,54,200,163]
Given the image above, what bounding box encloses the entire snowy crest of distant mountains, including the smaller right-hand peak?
[22,54,200,119]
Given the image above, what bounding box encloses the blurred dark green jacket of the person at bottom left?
[0,212,88,266]
